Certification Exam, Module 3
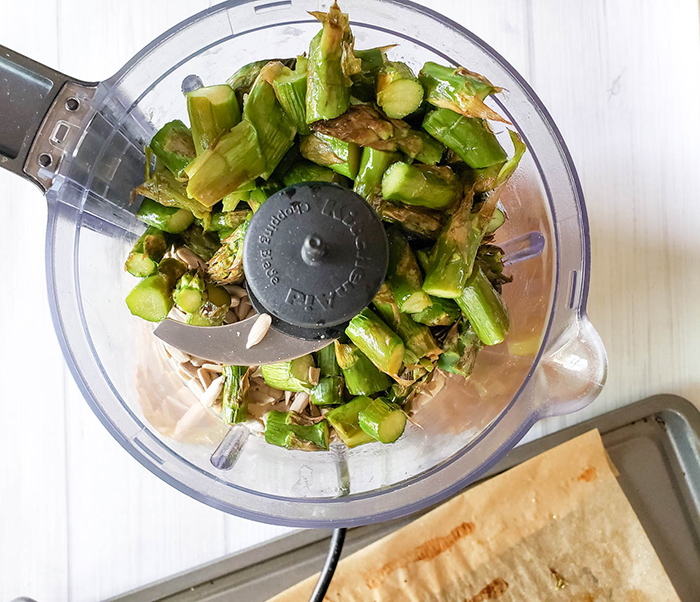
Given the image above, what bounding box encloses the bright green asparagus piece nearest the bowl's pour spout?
[456,265,510,345]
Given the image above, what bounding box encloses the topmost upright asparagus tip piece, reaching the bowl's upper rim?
[306,2,362,123]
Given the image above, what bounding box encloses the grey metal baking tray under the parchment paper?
[114,395,700,602]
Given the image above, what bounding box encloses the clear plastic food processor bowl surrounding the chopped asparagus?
[42,0,606,527]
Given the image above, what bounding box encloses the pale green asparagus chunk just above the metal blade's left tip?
[126,259,187,322]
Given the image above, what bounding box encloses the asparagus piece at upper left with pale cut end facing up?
[187,85,241,155]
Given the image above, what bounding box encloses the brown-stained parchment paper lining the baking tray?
[272,431,680,602]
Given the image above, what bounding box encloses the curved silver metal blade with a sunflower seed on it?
[154,316,333,366]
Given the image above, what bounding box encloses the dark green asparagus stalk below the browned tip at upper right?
[423,109,507,169]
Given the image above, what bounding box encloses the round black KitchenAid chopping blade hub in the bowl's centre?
[243,182,389,340]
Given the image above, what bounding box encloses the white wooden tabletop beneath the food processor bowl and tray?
[0,0,700,602]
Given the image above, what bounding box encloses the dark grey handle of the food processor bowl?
[0,45,95,192]
